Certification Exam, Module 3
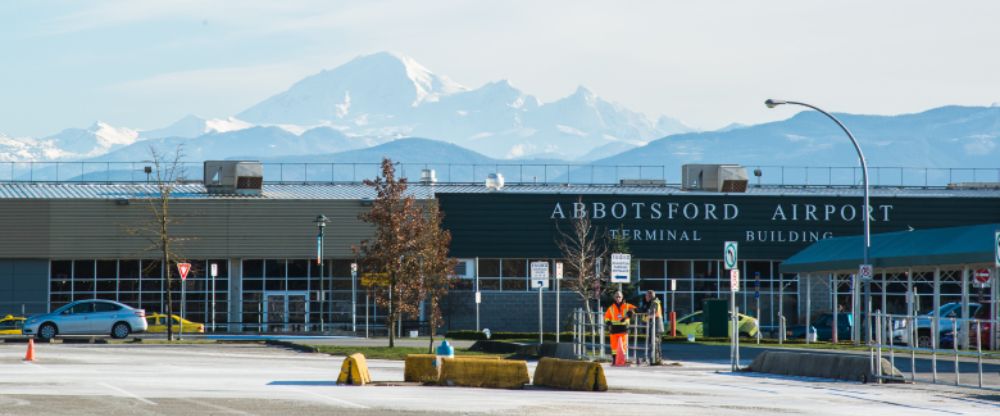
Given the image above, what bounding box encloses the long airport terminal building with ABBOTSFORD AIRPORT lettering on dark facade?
[0,161,1000,332]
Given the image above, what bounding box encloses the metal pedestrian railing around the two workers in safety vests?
[572,309,663,365]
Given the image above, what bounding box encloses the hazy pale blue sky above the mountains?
[0,0,1000,136]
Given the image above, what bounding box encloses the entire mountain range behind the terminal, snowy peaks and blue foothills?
[0,52,1000,180]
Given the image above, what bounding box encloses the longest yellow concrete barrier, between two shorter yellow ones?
[438,357,531,389]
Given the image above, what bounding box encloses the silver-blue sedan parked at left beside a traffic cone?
[22,299,147,341]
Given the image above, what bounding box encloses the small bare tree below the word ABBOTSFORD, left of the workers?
[556,201,608,323]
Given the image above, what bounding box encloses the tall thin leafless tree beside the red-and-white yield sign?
[127,145,187,341]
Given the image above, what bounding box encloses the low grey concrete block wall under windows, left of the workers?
[442,291,583,332]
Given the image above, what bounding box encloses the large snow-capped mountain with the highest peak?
[237,52,691,159]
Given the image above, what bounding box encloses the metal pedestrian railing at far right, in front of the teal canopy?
[869,311,1000,390]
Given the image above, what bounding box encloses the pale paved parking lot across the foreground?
[0,344,1000,416]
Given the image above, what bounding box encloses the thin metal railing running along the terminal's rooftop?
[0,161,1000,187]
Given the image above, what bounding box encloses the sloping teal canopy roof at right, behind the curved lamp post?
[781,224,1000,273]
